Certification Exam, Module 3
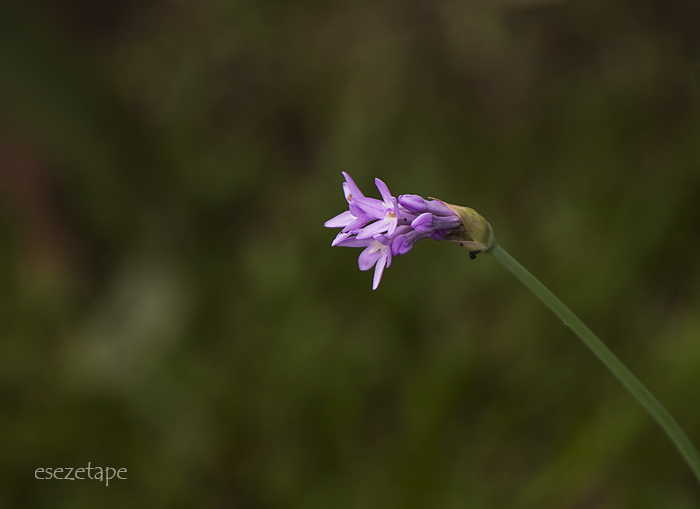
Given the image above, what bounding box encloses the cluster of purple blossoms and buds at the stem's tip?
[324,172,463,290]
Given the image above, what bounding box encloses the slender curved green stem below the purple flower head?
[487,244,700,482]
